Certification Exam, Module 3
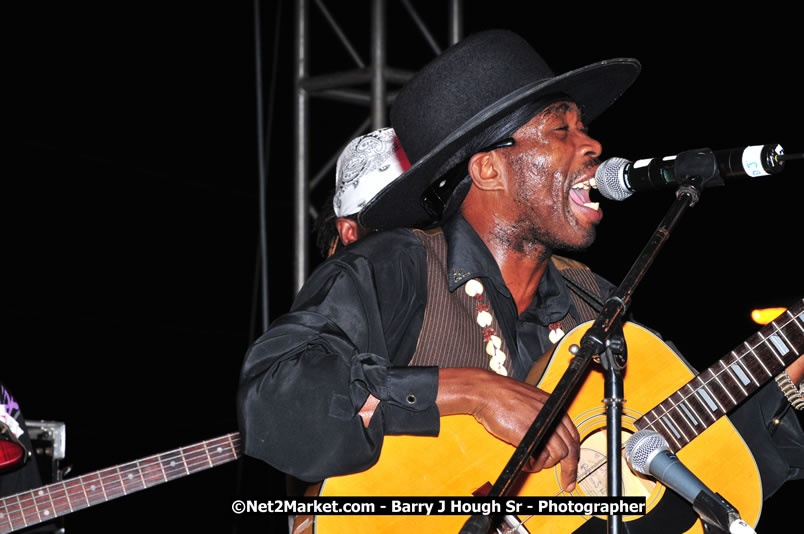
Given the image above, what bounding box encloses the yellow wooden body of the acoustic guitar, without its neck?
[314,323,762,534]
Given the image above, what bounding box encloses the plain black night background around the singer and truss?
[7,0,804,533]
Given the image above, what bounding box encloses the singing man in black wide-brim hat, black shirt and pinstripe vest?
[238,31,802,534]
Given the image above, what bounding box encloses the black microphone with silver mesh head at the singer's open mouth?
[595,145,798,200]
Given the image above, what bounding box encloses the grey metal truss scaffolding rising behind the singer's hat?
[292,0,463,291]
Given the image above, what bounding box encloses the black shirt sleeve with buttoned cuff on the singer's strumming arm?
[238,232,439,481]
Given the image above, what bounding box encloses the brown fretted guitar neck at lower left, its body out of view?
[0,432,241,532]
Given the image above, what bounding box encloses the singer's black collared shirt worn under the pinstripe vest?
[239,215,611,481]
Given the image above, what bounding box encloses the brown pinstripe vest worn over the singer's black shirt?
[409,229,600,384]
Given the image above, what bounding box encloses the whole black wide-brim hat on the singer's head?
[358,30,641,229]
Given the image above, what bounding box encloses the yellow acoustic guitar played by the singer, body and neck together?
[314,300,804,534]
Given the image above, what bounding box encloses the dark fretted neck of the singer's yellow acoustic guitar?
[635,299,804,452]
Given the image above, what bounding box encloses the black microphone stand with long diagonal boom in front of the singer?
[460,151,722,534]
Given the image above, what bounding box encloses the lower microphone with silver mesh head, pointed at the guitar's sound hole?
[625,429,755,534]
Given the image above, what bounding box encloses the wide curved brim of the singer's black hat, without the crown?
[358,58,641,230]
